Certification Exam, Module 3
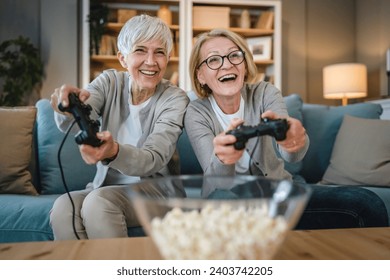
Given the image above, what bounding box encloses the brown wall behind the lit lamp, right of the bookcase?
[282,0,390,105]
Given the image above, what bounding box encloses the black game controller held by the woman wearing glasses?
[226,119,288,150]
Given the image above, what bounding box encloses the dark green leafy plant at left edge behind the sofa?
[0,36,44,106]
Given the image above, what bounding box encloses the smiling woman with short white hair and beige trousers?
[50,15,189,240]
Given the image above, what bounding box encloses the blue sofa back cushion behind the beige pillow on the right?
[301,103,383,183]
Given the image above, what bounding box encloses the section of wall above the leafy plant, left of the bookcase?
[0,0,80,98]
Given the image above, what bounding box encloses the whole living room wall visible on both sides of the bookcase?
[0,0,390,105]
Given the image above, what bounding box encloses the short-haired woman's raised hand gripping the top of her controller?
[50,84,90,115]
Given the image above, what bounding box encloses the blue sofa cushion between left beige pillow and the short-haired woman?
[36,99,96,194]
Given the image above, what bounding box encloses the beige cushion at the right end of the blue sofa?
[322,115,390,186]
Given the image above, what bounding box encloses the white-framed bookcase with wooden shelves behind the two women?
[84,0,282,90]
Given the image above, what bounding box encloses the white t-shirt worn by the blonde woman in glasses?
[208,95,250,173]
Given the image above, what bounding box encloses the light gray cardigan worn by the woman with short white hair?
[55,69,189,188]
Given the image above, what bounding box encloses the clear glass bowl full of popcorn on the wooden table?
[129,175,310,260]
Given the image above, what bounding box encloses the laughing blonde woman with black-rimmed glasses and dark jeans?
[184,29,388,229]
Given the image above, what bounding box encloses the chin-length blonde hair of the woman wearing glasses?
[189,29,257,98]
